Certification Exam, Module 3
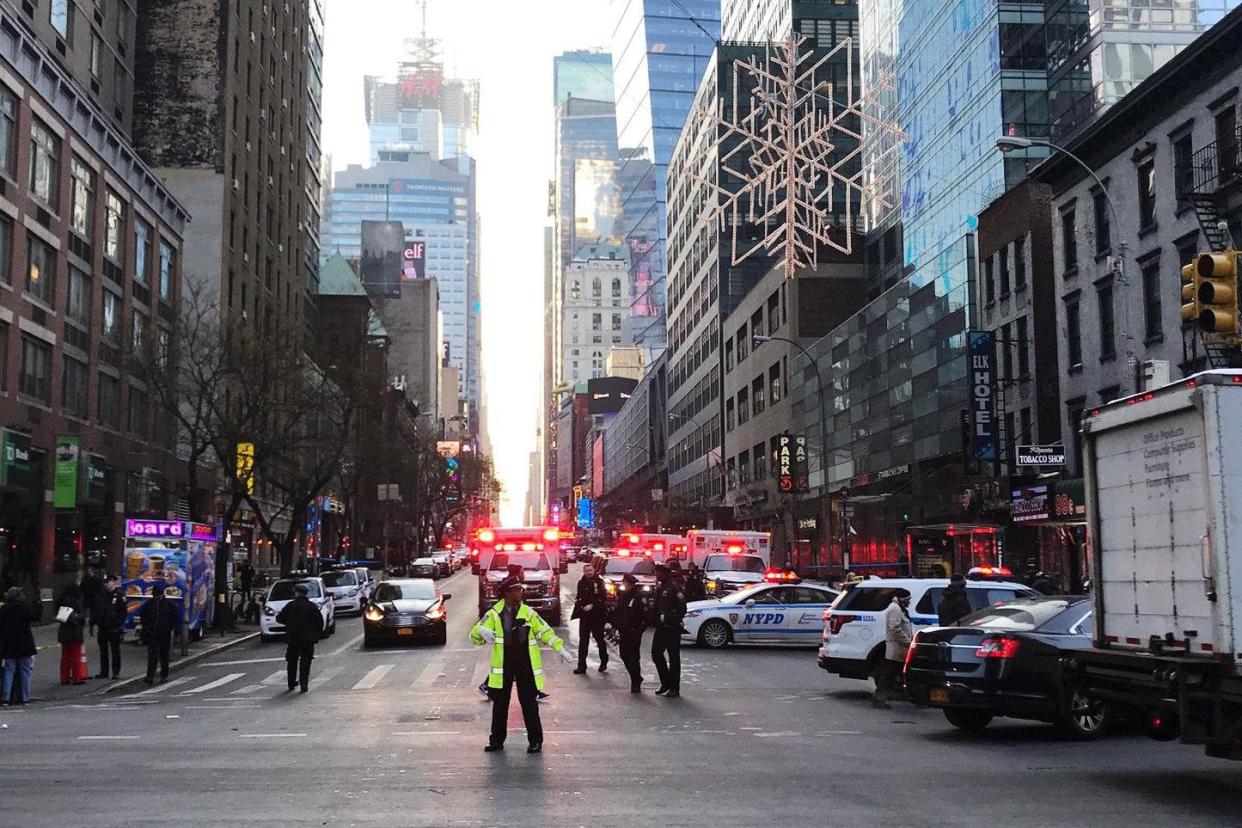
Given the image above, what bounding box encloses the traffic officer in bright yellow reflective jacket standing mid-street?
[469,576,574,754]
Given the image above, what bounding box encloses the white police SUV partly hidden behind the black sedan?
[820,578,1038,679]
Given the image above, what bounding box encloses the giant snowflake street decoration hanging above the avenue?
[702,37,904,278]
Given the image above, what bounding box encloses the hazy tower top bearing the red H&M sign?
[363,32,479,163]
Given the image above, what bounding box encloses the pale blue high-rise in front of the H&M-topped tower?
[320,153,482,420]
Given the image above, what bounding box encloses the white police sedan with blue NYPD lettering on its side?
[682,583,837,649]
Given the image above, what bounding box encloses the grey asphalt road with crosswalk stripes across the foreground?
[0,569,1242,828]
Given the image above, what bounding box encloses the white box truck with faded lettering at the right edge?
[1072,371,1242,760]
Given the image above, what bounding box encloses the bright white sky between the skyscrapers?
[323,0,612,525]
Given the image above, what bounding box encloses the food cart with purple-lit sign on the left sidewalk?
[120,518,220,638]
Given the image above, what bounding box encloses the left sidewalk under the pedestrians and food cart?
[20,623,258,704]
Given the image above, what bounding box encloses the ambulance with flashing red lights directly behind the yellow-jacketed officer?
[471,526,569,624]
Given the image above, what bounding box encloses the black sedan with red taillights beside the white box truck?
[905,596,1113,739]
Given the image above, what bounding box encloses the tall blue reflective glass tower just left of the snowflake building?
[612,0,720,365]
